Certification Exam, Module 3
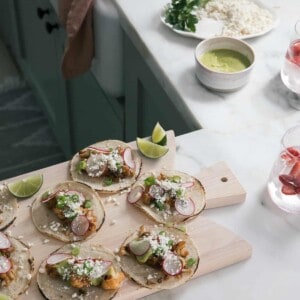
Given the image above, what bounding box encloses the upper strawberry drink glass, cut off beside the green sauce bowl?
[281,20,300,95]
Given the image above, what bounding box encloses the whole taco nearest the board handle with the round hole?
[127,170,205,224]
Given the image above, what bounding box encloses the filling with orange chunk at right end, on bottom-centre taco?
[45,253,125,290]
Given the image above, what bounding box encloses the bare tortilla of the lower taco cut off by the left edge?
[0,237,33,299]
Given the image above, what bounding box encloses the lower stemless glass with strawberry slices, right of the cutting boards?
[268,125,300,214]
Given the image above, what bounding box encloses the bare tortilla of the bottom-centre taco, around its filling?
[37,242,120,300]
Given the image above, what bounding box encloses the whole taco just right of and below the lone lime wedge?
[31,181,105,242]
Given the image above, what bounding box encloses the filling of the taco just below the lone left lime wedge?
[41,189,97,236]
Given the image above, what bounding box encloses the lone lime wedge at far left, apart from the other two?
[7,174,43,198]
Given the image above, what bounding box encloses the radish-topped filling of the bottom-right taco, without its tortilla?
[120,226,198,286]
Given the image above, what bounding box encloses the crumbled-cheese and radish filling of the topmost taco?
[76,146,135,186]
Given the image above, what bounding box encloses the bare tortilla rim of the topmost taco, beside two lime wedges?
[71,140,142,193]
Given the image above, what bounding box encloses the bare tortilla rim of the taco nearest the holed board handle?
[132,170,206,224]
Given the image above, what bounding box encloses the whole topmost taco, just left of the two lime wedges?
[71,140,142,192]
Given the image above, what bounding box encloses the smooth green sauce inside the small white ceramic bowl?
[199,49,251,73]
